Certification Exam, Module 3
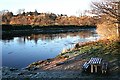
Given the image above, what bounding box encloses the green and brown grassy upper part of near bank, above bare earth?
[57,40,120,72]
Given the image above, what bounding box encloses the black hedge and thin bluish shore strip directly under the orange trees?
[2,24,96,33]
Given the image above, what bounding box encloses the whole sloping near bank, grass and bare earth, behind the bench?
[29,40,120,75]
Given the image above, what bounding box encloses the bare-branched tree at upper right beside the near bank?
[91,0,120,40]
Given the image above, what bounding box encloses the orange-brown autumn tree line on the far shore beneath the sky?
[2,10,98,26]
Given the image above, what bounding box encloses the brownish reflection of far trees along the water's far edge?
[2,30,96,44]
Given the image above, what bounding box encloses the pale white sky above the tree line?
[0,0,95,16]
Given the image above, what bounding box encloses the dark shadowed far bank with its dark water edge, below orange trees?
[2,24,96,39]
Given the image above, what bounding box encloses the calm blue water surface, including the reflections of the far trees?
[0,30,99,68]
